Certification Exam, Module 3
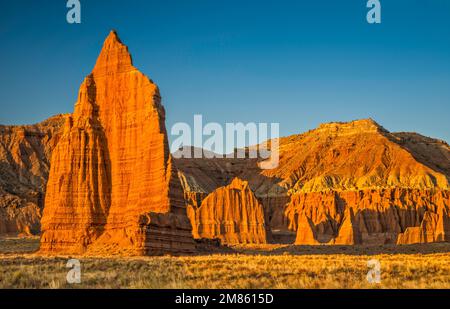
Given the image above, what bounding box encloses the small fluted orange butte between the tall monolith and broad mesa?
[188,178,266,244]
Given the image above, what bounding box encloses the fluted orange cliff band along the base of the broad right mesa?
[286,188,450,245]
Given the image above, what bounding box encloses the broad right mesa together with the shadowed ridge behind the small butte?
[176,119,450,245]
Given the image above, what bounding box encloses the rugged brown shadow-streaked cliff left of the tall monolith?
[0,115,65,236]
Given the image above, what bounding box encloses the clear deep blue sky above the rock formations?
[0,0,450,145]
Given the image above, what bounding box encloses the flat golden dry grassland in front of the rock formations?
[0,240,450,289]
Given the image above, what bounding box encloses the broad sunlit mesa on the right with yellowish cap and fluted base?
[280,120,450,245]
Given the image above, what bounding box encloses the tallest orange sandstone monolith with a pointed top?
[40,32,194,255]
